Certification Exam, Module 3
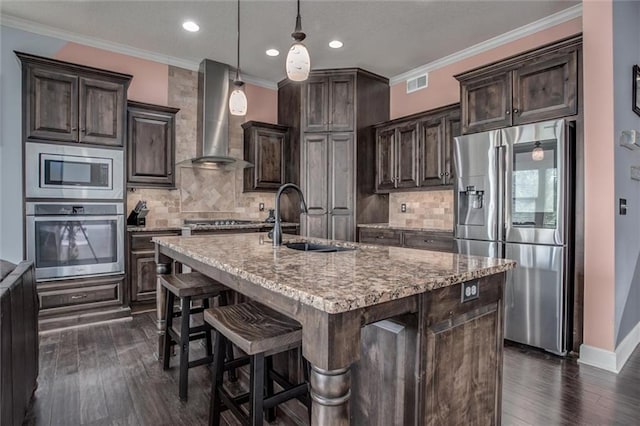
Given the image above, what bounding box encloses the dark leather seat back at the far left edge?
[0,261,39,426]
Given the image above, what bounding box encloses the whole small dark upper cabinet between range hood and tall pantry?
[242,121,289,192]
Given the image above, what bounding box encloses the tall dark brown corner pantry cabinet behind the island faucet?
[278,68,389,241]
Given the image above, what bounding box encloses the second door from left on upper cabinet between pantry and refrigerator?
[396,122,418,188]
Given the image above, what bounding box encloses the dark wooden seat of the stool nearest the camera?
[204,302,302,355]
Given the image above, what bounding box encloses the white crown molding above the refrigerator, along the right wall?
[389,4,582,86]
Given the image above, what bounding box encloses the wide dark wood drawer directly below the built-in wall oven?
[38,278,123,313]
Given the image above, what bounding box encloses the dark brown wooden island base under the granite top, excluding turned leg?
[351,273,505,426]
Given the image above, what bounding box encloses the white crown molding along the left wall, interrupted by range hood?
[0,14,278,90]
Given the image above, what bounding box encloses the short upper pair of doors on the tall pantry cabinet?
[303,75,355,132]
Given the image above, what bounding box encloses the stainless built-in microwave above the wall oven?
[25,142,124,199]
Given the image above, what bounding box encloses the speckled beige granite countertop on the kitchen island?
[153,233,516,313]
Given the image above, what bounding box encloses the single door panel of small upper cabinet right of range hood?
[254,129,286,189]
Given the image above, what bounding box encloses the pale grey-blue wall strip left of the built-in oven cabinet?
[0,26,65,263]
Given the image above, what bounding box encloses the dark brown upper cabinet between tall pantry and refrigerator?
[375,104,460,193]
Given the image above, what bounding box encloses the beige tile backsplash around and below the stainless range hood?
[127,66,275,226]
